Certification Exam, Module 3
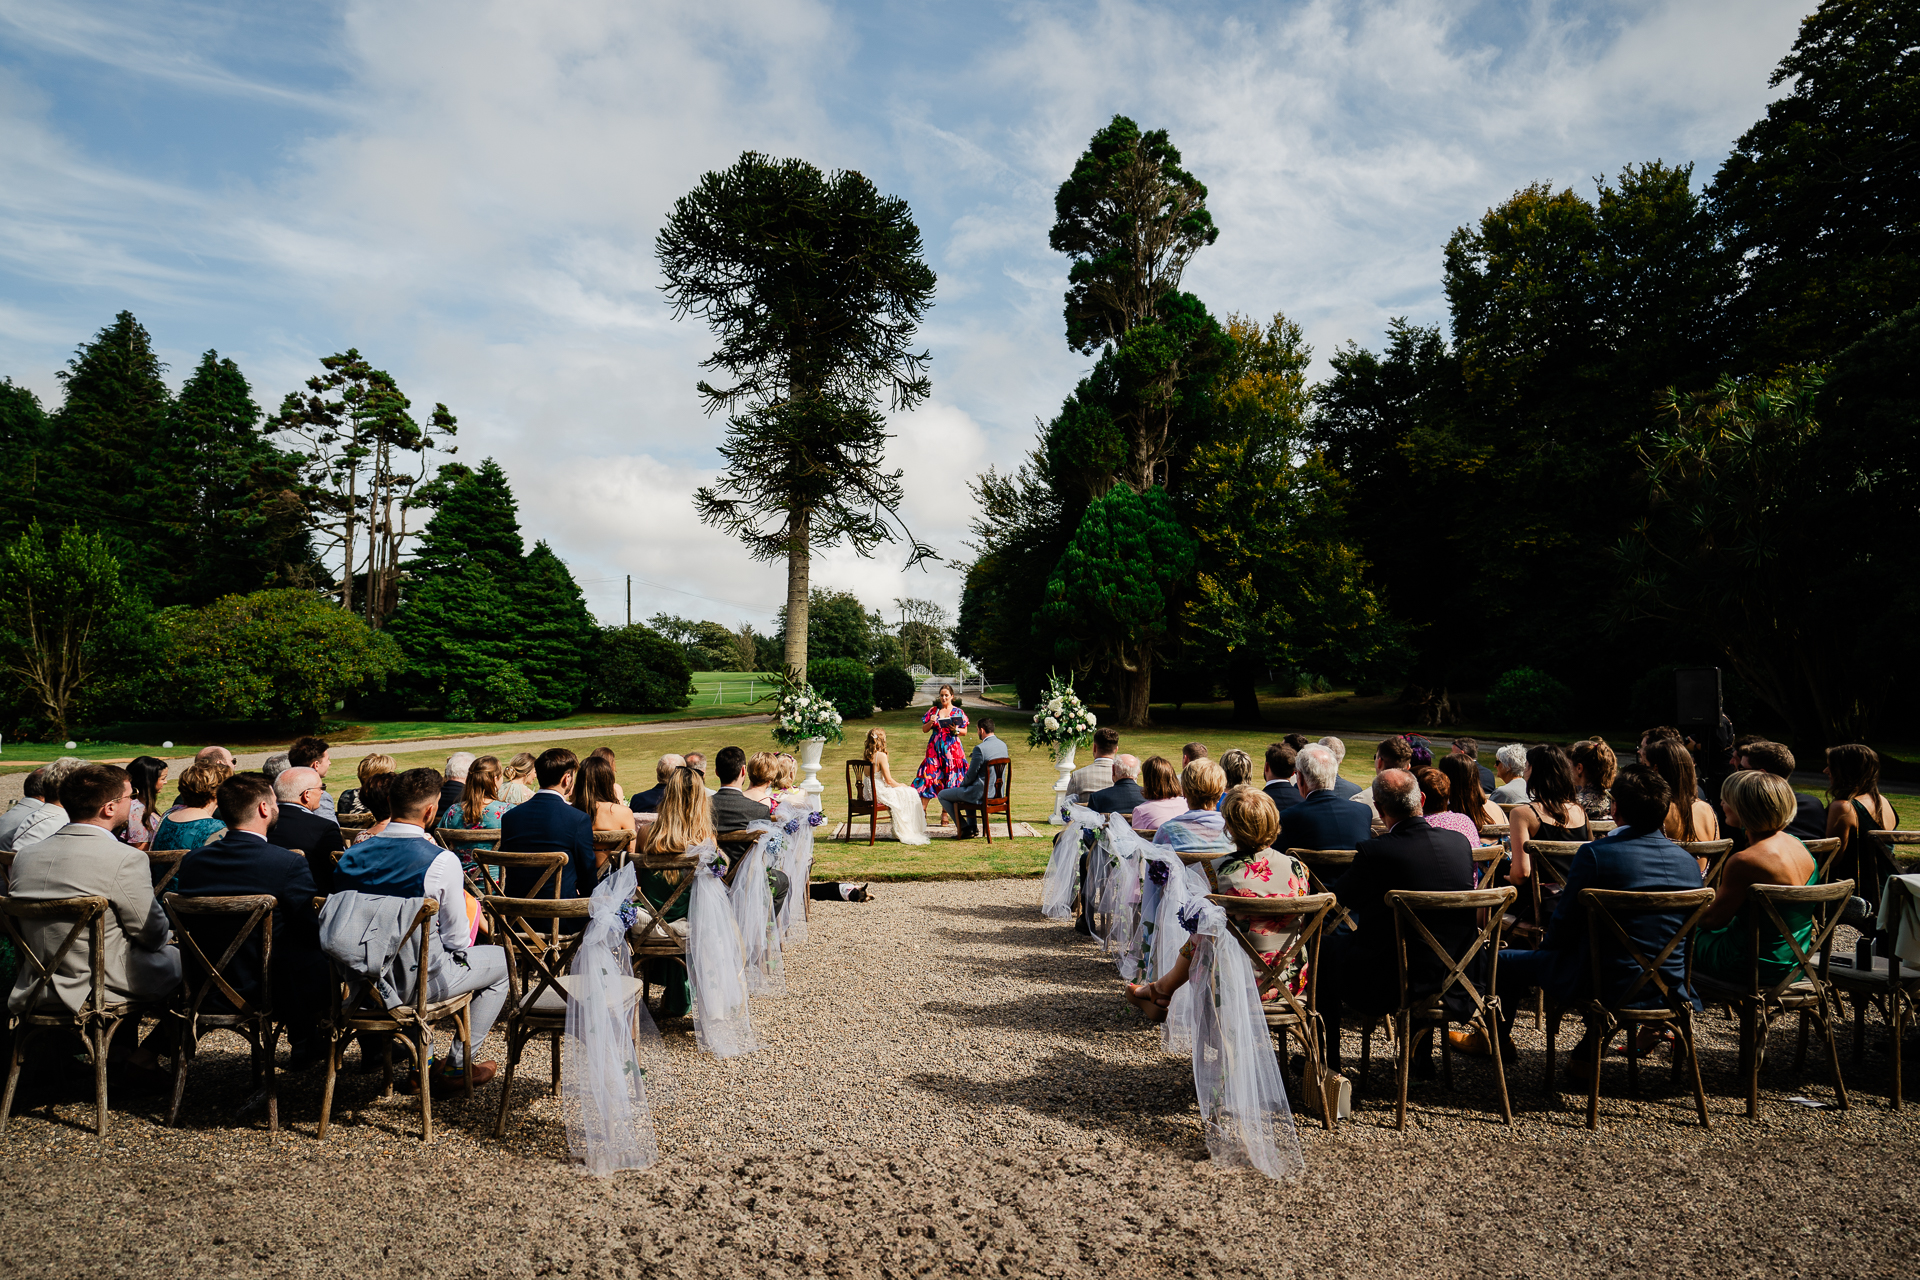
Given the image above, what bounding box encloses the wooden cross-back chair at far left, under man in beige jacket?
[0,896,171,1138]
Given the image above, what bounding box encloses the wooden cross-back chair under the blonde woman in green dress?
[1692,881,1853,1117]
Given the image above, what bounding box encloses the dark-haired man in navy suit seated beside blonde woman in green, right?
[1453,764,1699,1086]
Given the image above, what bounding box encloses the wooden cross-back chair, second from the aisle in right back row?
[1386,885,1517,1128]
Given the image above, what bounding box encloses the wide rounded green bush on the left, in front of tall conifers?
[156,589,403,727]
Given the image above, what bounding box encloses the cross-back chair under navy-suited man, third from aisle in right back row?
[1546,889,1713,1128]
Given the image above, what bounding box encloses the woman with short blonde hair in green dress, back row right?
[1704,771,1820,988]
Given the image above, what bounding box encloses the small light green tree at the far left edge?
[0,522,129,737]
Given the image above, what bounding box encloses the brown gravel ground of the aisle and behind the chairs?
[0,879,1920,1280]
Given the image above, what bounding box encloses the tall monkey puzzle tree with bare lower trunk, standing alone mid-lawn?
[655,152,935,670]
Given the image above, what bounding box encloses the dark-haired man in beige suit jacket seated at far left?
[8,764,180,1069]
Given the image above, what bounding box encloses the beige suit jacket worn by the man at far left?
[8,821,180,1013]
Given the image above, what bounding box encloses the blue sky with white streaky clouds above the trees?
[0,0,1812,629]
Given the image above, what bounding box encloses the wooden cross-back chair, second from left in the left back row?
[165,894,280,1134]
